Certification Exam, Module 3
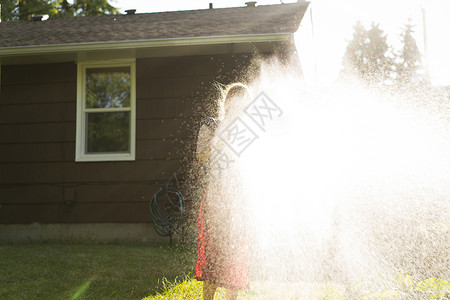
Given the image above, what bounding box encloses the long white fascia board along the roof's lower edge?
[0,33,293,57]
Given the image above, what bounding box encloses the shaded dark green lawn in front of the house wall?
[0,244,195,300]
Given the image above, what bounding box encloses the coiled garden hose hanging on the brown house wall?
[150,183,184,236]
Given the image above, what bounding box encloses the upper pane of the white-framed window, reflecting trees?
[86,67,131,108]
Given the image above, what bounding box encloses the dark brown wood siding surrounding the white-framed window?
[0,55,255,224]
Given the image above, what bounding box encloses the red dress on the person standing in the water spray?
[195,118,249,290]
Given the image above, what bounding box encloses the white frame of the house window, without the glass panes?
[75,59,136,162]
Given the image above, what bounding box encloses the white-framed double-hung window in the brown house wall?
[75,61,136,161]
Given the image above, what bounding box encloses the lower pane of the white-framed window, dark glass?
[86,112,130,153]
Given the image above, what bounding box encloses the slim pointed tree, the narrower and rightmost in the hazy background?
[396,20,425,85]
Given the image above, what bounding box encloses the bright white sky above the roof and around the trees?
[110,0,450,85]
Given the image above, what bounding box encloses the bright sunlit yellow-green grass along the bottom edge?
[143,274,450,300]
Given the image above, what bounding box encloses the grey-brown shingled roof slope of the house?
[0,1,308,49]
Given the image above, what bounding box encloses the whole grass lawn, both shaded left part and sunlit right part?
[0,244,450,300]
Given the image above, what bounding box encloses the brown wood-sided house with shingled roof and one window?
[0,1,308,241]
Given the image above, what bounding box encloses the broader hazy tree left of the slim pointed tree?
[341,21,394,84]
